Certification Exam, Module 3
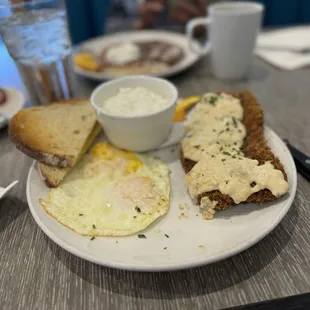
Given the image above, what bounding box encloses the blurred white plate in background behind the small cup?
[74,30,200,81]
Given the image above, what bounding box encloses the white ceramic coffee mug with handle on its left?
[186,1,264,80]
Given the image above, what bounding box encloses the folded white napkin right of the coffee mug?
[255,26,310,70]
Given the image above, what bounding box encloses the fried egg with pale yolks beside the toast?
[40,143,170,236]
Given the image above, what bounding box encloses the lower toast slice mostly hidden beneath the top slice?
[39,123,101,187]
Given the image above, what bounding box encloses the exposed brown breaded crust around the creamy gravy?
[180,92,287,210]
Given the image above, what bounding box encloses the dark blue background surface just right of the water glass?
[65,0,111,45]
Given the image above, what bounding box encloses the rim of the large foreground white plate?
[26,126,297,272]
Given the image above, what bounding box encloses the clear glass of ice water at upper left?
[0,0,74,105]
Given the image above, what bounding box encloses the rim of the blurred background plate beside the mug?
[73,30,205,81]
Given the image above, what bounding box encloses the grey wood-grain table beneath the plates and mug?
[0,39,310,310]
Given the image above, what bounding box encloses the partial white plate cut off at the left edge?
[0,87,25,129]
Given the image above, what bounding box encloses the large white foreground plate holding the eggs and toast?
[27,128,297,271]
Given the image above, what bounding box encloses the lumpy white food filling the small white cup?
[102,87,169,116]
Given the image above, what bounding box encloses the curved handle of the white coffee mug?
[186,17,211,56]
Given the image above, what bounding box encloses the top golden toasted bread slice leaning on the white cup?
[9,99,96,168]
